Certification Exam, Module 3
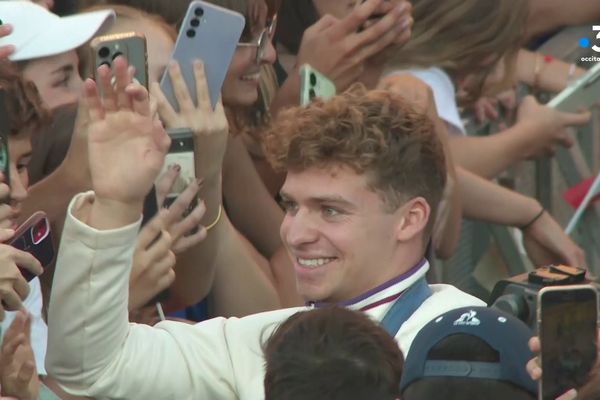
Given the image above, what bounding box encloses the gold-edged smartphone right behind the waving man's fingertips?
[90,32,148,89]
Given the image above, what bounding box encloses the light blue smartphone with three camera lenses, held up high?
[160,1,246,110]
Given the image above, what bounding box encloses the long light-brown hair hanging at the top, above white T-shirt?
[389,0,528,98]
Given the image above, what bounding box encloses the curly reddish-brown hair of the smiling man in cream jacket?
[264,85,446,235]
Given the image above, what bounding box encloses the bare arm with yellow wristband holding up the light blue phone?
[152,61,279,314]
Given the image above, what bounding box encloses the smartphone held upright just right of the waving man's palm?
[159,128,198,223]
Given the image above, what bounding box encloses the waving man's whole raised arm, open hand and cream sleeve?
[46,64,294,400]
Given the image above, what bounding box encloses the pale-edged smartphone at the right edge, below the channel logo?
[546,63,600,112]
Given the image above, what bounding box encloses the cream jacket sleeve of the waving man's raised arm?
[46,194,239,400]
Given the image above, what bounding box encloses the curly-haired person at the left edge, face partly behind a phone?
[0,60,47,375]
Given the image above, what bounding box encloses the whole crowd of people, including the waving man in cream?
[0,0,600,400]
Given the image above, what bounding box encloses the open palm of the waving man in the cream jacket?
[84,57,170,216]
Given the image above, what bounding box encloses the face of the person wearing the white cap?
[22,50,83,110]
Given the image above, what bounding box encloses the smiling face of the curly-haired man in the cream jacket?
[281,167,405,302]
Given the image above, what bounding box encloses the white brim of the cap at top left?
[10,10,115,61]
